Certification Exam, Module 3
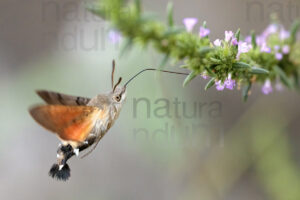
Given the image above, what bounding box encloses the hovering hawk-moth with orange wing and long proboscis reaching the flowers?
[29,61,188,181]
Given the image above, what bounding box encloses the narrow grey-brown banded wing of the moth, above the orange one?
[36,90,91,106]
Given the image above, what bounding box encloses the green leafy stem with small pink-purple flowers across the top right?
[90,0,300,99]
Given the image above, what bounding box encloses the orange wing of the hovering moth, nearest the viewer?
[29,105,103,142]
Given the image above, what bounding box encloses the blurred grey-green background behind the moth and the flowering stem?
[0,0,300,200]
